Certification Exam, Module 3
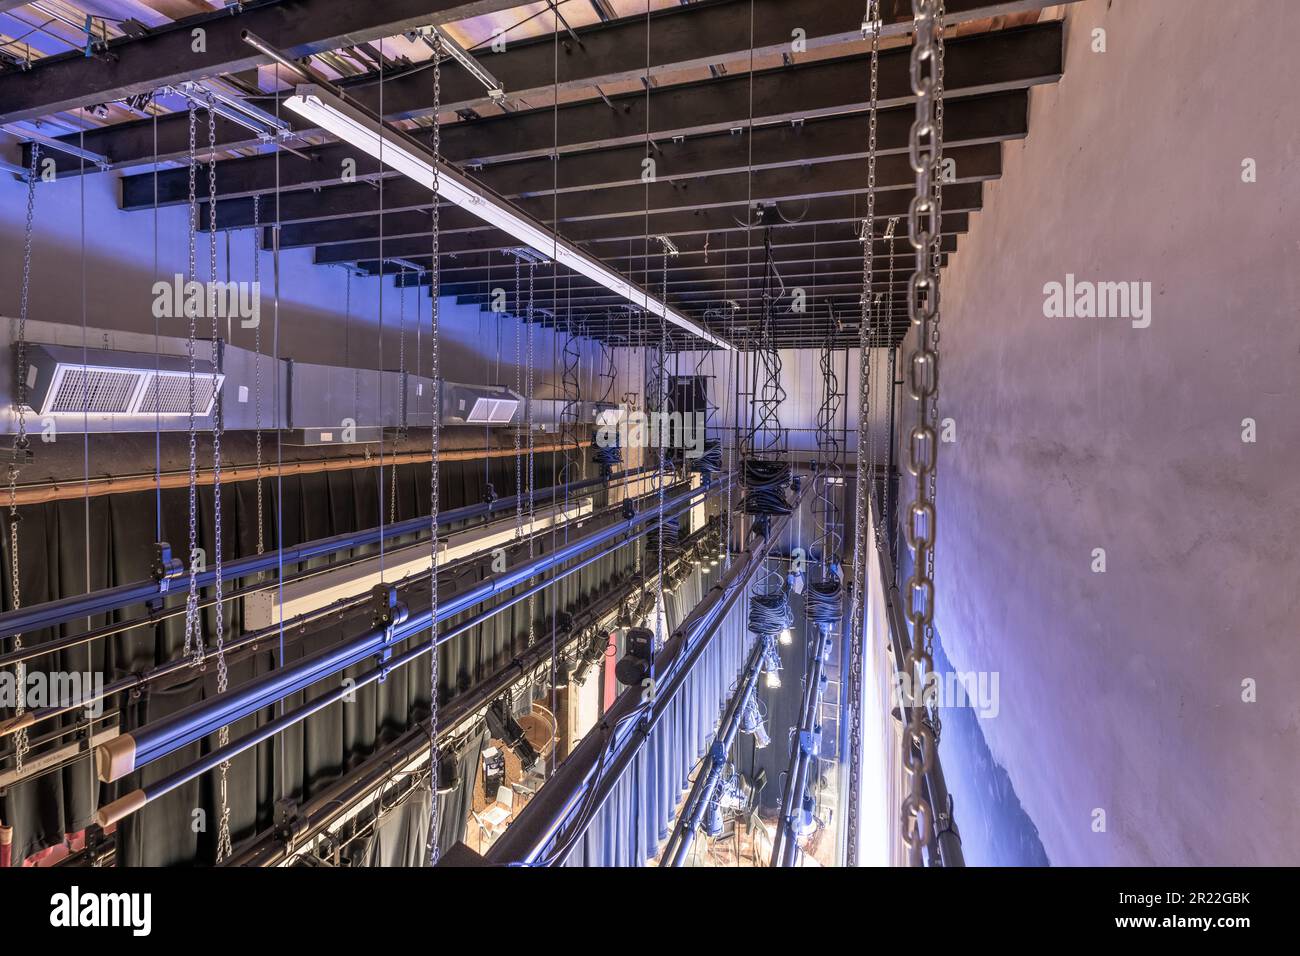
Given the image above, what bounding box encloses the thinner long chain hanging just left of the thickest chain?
[846,0,880,866]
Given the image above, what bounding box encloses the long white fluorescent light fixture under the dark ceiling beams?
[285,83,735,351]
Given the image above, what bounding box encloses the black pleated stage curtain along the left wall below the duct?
[0,454,633,866]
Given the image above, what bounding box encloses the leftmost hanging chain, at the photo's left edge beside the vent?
[9,143,40,773]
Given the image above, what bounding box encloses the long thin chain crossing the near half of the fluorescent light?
[429,34,442,866]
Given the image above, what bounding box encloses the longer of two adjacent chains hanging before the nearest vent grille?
[208,108,234,864]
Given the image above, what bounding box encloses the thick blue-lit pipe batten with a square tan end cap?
[96,481,728,782]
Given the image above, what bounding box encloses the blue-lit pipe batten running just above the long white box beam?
[0,467,650,640]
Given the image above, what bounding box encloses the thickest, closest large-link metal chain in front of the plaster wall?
[901,0,939,866]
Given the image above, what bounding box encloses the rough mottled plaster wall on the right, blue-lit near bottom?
[904,0,1300,865]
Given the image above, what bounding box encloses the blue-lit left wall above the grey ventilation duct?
[0,137,590,395]
